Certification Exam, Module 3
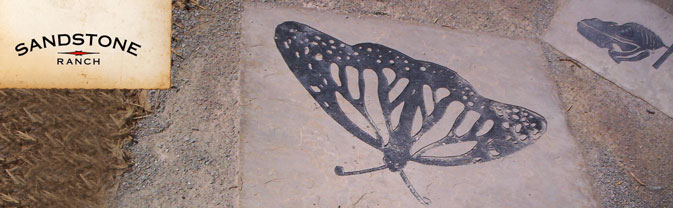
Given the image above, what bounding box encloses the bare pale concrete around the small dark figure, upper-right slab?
[543,0,673,116]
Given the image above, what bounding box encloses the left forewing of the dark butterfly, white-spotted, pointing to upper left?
[274,21,385,150]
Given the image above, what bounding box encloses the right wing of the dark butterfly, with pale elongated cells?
[411,59,547,166]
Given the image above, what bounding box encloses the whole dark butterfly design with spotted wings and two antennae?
[274,21,547,204]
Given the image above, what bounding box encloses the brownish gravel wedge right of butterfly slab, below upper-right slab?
[543,44,673,207]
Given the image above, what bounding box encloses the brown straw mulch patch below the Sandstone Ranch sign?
[0,90,144,207]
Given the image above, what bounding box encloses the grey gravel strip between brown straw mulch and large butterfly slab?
[111,1,241,207]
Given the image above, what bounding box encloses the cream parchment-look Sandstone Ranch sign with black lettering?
[0,0,171,89]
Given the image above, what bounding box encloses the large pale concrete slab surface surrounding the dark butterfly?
[240,5,595,207]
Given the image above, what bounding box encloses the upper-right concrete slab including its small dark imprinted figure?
[543,0,673,116]
